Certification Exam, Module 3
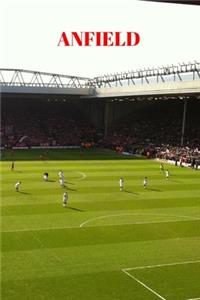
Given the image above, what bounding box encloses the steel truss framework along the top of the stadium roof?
[0,61,200,90]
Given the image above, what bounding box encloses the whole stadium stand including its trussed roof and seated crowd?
[0,61,200,167]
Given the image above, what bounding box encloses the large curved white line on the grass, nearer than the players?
[80,213,200,227]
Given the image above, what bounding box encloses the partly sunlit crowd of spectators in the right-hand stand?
[103,101,200,167]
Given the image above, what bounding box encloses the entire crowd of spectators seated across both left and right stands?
[0,98,200,165]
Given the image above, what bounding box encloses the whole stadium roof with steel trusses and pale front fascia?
[0,61,200,98]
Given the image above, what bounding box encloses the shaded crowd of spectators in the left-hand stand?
[1,117,96,148]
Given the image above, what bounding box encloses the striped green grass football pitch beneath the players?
[1,150,200,300]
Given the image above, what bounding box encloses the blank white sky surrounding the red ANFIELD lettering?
[0,0,200,77]
